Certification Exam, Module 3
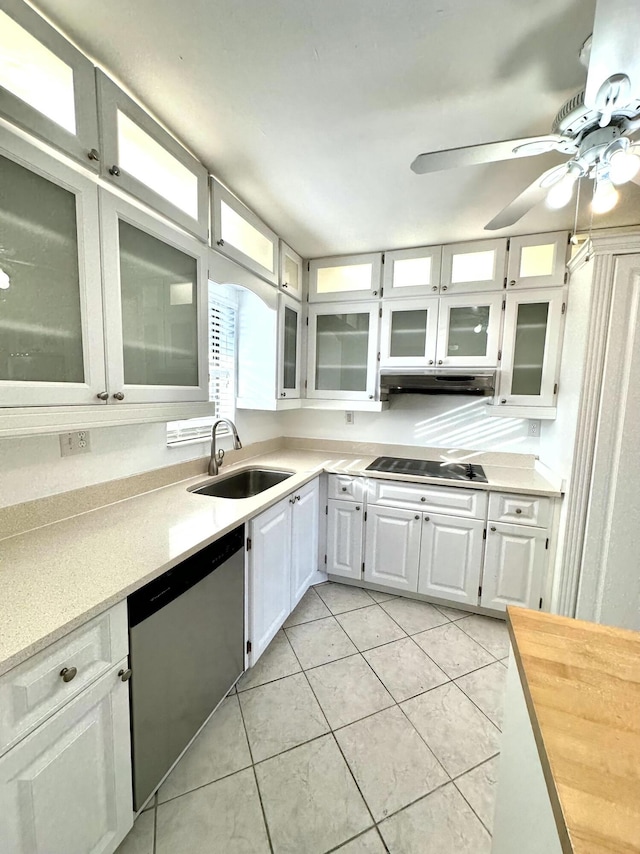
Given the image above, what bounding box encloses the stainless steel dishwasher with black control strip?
[128,526,244,810]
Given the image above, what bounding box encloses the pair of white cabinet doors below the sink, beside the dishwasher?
[247,478,320,666]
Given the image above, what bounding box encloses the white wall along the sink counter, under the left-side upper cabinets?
[0,411,282,507]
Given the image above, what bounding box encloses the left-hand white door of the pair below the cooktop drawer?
[364,507,422,593]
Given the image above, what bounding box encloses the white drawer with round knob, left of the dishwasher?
[0,602,129,753]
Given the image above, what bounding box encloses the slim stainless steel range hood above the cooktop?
[380,368,496,395]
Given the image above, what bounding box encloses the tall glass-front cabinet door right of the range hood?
[498,289,566,406]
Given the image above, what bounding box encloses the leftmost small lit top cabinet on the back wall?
[309,252,382,302]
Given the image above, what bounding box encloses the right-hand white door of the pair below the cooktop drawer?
[418,514,485,605]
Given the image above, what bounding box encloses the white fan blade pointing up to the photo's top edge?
[584,0,640,115]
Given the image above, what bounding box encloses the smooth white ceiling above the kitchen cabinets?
[36,0,640,257]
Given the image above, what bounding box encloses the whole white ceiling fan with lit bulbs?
[411,0,640,231]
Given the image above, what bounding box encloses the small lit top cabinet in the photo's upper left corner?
[0,0,100,169]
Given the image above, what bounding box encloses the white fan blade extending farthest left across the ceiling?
[411,134,570,175]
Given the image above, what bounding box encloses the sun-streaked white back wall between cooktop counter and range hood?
[282,394,539,454]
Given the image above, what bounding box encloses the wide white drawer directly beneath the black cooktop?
[369,478,487,519]
